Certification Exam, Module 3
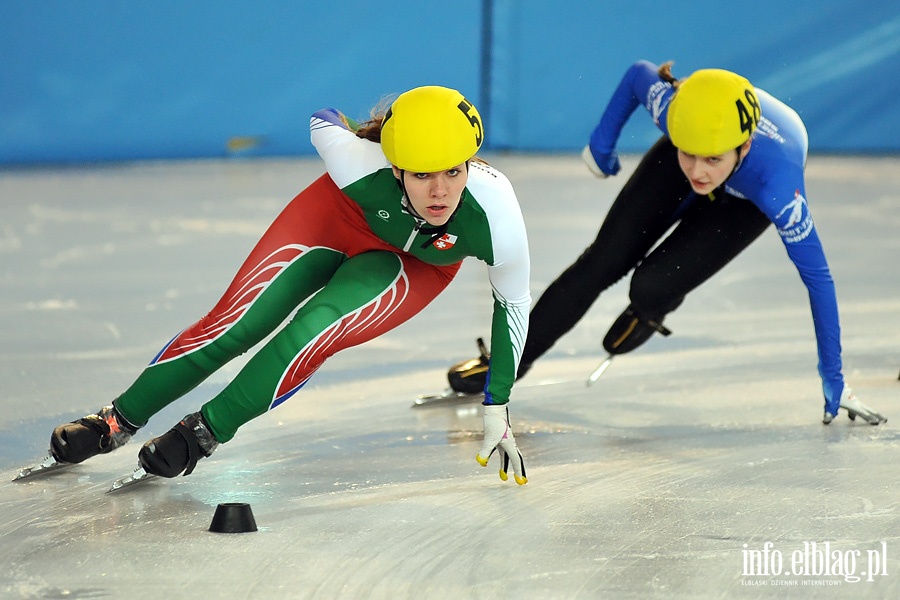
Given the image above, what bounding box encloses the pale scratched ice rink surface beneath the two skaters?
[0,155,900,600]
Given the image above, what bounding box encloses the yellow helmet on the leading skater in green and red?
[381,85,484,173]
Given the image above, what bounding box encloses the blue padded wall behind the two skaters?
[0,0,900,164]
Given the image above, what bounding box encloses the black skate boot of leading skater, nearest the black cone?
[138,412,219,477]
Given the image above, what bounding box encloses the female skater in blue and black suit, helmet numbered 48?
[448,61,886,425]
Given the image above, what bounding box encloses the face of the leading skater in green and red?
[394,163,469,226]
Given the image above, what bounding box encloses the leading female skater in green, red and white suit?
[50,86,531,485]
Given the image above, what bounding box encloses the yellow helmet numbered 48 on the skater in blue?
[666,69,761,156]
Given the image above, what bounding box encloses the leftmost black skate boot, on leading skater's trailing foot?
[50,406,138,464]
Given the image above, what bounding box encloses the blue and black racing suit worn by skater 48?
[519,61,844,415]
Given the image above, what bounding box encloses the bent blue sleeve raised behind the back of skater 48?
[588,60,673,175]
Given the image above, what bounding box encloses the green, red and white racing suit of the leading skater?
[115,109,531,442]
